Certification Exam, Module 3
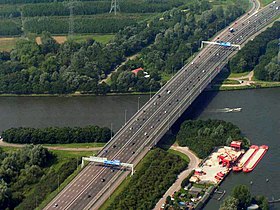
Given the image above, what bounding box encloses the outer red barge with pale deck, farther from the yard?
[243,145,268,173]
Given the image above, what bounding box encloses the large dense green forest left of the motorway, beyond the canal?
[0,0,244,95]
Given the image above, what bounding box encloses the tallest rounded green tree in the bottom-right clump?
[232,185,252,209]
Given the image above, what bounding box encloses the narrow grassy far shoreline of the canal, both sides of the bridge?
[0,82,280,98]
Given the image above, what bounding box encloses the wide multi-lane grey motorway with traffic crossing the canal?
[45,0,280,210]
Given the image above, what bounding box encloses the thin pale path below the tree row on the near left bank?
[0,139,103,152]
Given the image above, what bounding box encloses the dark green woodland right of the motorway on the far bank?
[229,21,280,81]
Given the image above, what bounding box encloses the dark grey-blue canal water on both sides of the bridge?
[0,89,280,210]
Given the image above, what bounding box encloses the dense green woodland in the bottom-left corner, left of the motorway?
[0,145,79,210]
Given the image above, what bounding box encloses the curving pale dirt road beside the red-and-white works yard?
[154,145,201,210]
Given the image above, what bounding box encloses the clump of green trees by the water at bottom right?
[219,185,269,210]
